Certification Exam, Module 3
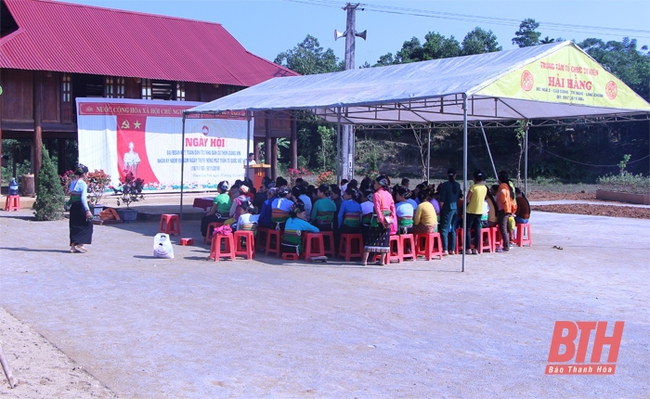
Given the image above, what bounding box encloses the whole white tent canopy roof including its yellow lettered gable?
[186,41,650,124]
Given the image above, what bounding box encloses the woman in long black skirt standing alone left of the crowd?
[70,164,93,253]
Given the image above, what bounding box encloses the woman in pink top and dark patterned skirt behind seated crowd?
[363,175,397,265]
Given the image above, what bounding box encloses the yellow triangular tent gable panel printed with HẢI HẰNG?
[477,46,650,111]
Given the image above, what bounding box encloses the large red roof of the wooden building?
[0,0,296,86]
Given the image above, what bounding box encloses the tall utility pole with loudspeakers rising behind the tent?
[334,3,367,183]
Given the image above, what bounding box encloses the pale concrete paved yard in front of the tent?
[0,205,650,398]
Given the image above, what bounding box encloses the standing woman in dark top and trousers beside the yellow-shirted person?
[440,168,462,255]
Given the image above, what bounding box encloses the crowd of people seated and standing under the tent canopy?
[201,168,530,264]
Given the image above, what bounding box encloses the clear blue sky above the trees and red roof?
[62,0,650,66]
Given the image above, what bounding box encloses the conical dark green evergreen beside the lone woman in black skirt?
[34,146,65,220]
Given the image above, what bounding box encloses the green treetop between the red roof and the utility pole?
[274,35,345,75]
